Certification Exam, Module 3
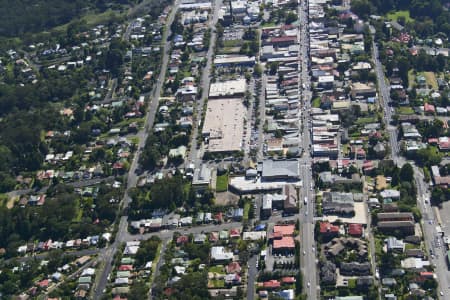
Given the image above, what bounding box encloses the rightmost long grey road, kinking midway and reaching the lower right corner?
[371,36,450,299]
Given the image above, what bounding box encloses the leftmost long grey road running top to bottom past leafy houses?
[95,0,180,299]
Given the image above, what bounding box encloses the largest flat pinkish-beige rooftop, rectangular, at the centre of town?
[202,98,246,152]
